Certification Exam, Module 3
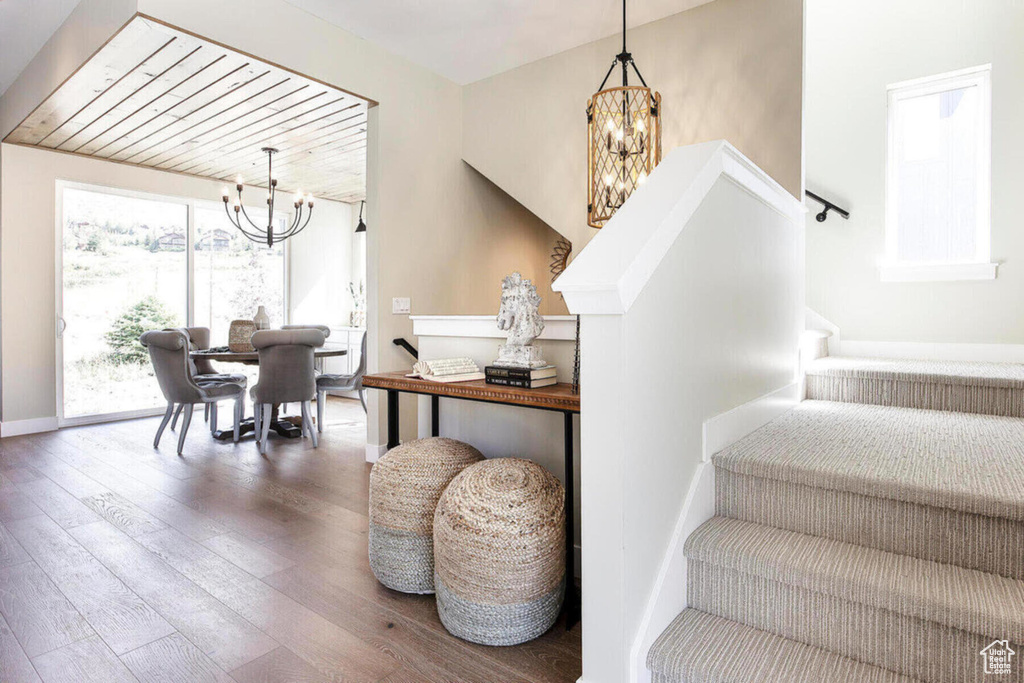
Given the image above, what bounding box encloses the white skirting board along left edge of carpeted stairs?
[630,382,801,683]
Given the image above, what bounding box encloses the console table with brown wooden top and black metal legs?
[362,373,580,628]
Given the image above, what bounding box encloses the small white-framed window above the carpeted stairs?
[883,66,995,280]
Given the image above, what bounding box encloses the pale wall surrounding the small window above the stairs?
[805,0,1024,344]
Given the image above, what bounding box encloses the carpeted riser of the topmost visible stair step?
[806,375,1024,418]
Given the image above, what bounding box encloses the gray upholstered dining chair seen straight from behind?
[252,328,324,453]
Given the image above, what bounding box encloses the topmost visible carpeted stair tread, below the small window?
[807,356,1024,389]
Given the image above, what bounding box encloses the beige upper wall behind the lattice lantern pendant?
[463,0,803,252]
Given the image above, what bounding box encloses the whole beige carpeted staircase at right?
[647,358,1024,683]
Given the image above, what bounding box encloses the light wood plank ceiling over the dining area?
[4,16,369,202]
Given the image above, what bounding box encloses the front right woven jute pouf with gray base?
[434,458,565,645]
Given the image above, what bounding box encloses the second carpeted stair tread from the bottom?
[685,517,1024,643]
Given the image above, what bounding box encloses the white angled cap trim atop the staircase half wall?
[552,140,807,315]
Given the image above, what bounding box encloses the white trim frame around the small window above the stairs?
[882,65,996,282]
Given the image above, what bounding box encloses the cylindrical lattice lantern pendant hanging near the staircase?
[587,0,662,227]
